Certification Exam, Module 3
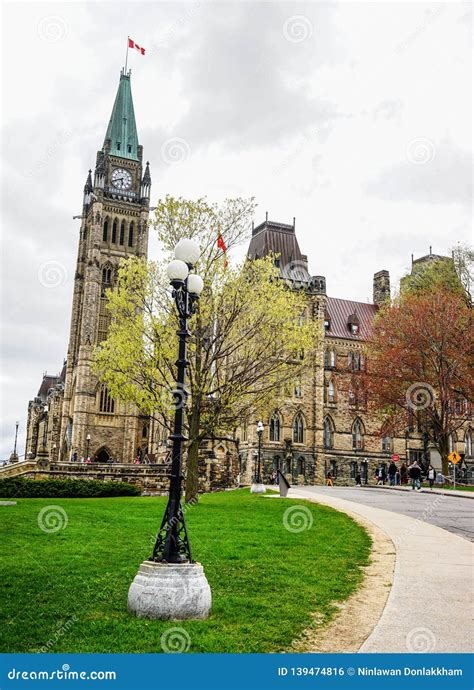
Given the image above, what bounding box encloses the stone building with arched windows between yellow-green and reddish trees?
[238,216,474,484]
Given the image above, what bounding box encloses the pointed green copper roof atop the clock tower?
[105,72,138,160]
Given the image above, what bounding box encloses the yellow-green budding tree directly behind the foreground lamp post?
[96,197,320,501]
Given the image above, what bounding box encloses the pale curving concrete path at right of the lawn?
[288,487,474,653]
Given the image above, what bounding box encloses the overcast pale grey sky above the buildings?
[0,0,472,458]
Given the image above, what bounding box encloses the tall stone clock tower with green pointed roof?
[60,71,151,462]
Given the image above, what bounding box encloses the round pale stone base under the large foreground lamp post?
[128,561,212,620]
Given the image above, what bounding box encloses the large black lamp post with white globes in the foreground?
[151,239,204,563]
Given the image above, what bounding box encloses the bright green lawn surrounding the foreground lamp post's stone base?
[0,490,370,653]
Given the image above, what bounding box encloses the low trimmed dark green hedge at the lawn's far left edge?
[0,477,141,498]
